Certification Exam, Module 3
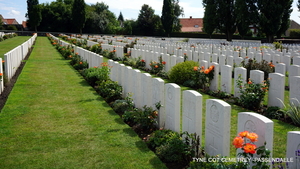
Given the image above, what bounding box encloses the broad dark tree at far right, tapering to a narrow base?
[257,0,289,43]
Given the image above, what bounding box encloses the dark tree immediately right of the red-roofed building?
[202,0,218,38]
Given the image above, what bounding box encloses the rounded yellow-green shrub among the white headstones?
[169,61,199,84]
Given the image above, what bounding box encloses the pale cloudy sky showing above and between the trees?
[0,0,300,24]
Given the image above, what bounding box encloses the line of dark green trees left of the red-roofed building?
[26,0,183,36]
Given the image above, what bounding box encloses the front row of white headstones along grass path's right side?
[109,60,300,166]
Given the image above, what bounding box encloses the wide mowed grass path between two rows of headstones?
[0,37,165,169]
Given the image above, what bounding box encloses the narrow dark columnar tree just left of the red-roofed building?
[161,0,175,37]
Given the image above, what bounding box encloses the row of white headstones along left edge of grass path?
[0,34,37,94]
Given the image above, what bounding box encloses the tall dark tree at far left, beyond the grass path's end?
[25,0,42,31]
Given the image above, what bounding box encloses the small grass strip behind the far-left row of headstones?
[0,36,31,58]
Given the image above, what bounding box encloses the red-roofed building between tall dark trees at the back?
[180,17,203,32]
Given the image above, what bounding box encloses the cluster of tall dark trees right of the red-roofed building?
[202,0,294,42]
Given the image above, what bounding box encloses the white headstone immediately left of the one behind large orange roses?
[205,99,231,156]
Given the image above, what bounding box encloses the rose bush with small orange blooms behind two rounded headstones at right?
[242,59,275,80]
